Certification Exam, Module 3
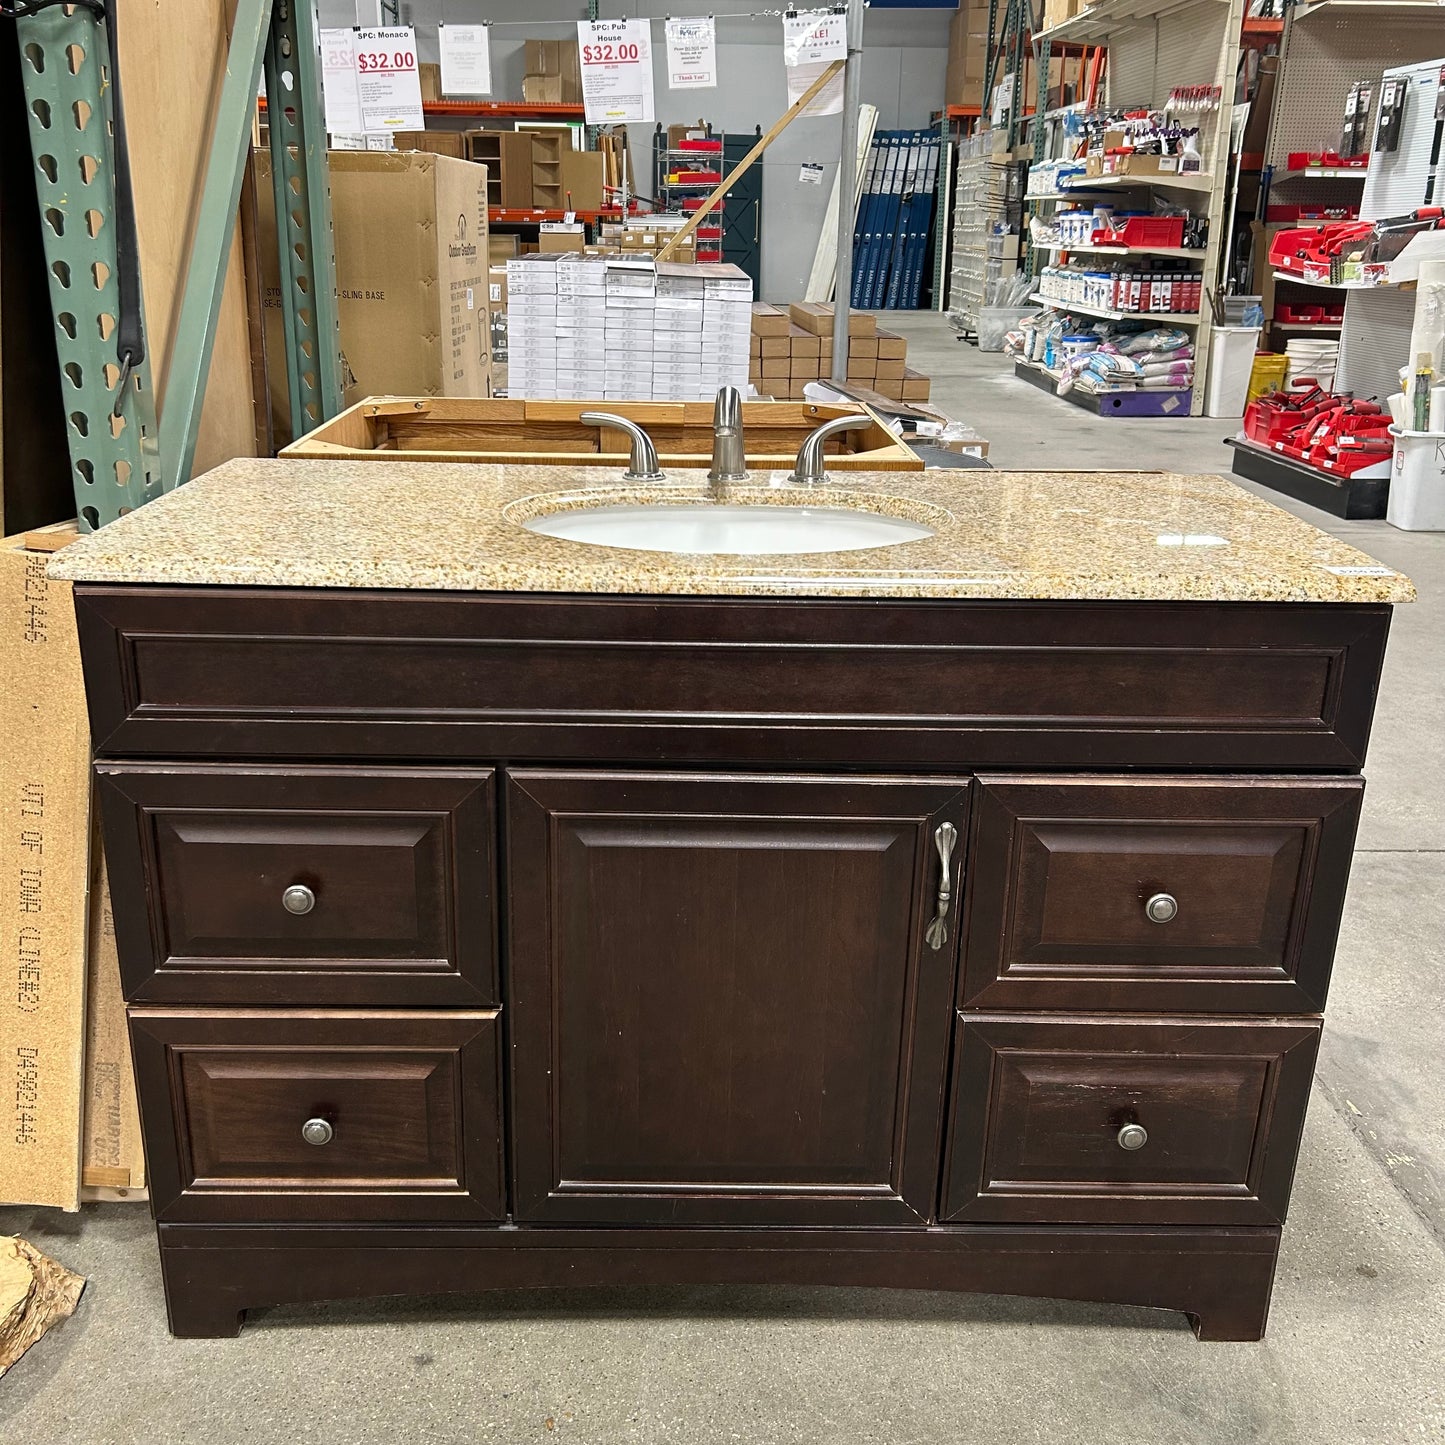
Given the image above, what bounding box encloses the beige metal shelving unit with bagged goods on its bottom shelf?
[1026,0,1244,416]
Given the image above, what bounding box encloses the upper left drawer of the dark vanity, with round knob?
[97,763,499,1007]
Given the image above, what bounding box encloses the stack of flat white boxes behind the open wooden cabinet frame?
[507,253,753,402]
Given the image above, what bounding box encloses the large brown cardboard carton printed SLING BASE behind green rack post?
[256,150,491,448]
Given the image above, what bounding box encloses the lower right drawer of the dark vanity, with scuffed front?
[941,1014,1319,1225]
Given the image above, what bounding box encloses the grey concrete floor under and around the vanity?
[0,316,1445,1445]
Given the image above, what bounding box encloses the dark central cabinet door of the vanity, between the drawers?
[506,772,967,1224]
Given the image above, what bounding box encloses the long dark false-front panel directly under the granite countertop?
[77,585,1390,770]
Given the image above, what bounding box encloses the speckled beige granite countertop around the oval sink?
[51,460,1415,603]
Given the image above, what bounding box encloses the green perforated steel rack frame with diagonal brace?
[16,0,341,532]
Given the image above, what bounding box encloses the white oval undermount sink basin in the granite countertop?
[522,501,933,556]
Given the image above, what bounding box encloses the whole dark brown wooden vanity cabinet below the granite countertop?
[77,585,1389,1340]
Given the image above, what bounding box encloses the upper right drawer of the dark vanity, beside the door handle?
[959,776,1364,1013]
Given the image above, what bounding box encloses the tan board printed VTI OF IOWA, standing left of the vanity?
[0,538,91,1209]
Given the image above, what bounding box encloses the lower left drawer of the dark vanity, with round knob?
[130,1009,504,1222]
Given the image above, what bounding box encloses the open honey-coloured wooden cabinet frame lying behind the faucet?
[282,397,923,471]
